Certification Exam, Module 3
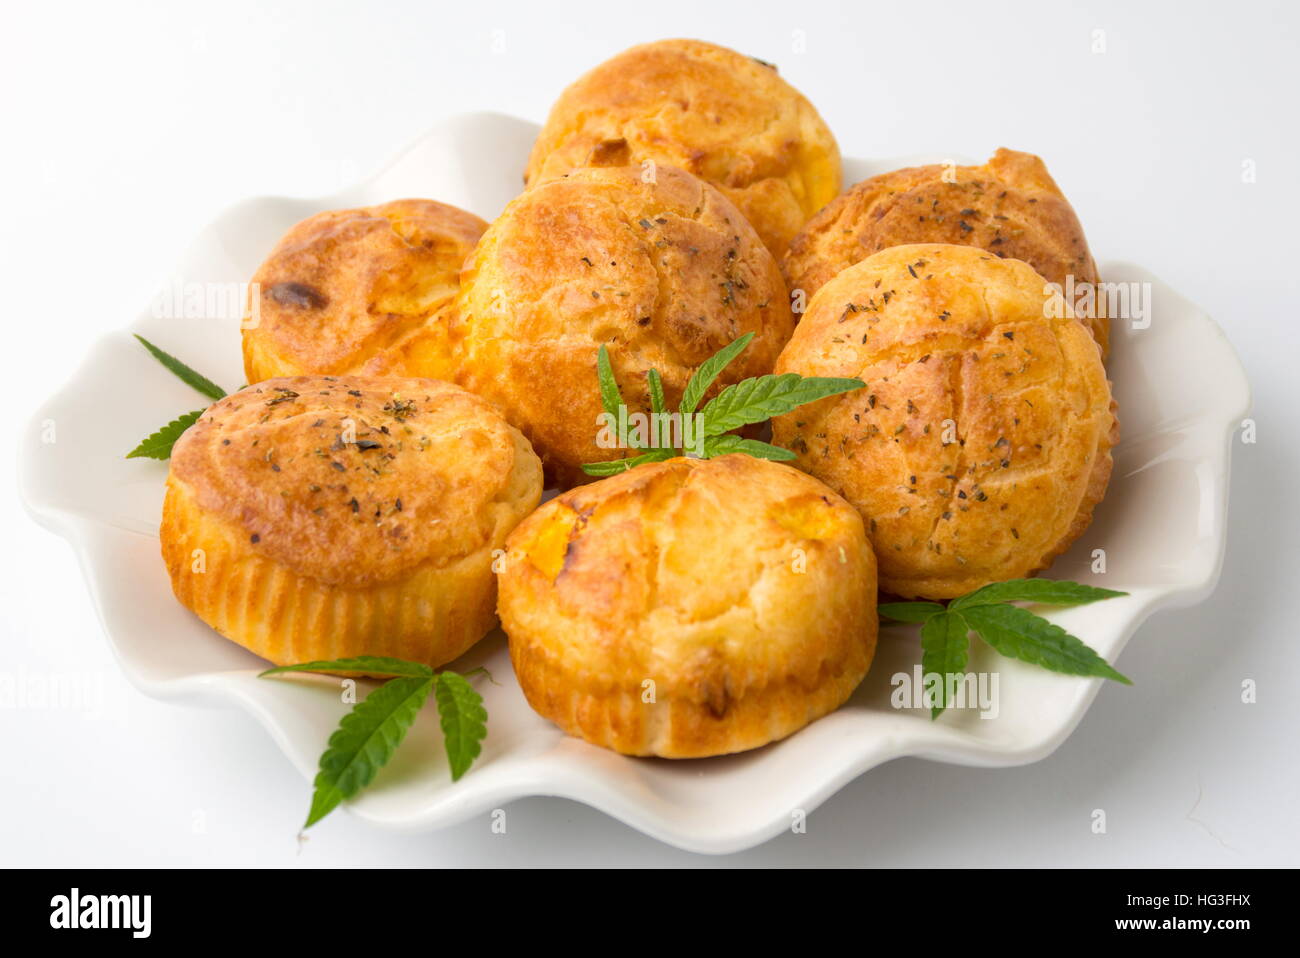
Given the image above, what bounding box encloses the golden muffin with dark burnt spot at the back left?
[243,200,488,382]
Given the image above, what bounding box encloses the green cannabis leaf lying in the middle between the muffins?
[582,333,866,476]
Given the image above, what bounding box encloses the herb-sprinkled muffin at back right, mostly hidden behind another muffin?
[781,149,1110,356]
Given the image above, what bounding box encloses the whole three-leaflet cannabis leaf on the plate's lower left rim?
[259,655,488,828]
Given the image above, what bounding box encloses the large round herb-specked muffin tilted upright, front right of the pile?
[772,246,1118,599]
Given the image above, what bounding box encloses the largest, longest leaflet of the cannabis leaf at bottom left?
[303,676,436,828]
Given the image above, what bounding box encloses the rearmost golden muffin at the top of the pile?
[524,40,840,256]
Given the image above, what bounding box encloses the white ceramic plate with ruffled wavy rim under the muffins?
[20,114,1249,853]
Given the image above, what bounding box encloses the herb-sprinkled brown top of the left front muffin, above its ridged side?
[170,376,541,586]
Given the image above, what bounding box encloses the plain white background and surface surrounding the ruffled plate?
[0,0,1300,866]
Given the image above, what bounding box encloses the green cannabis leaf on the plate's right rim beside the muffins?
[879,578,1132,719]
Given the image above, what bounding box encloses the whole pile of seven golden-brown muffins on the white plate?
[163,40,1118,758]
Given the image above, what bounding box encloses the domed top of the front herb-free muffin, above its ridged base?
[502,454,875,691]
